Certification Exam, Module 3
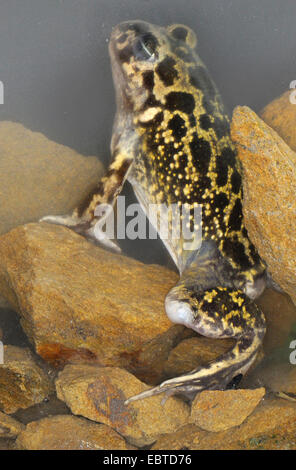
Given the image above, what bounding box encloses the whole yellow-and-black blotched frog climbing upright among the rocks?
[42,20,267,404]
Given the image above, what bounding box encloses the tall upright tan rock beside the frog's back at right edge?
[231,106,296,303]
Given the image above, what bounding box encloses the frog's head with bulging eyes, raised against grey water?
[109,21,196,116]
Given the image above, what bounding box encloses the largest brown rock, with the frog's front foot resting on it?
[0,223,180,372]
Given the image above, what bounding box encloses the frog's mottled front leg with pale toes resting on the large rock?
[40,153,133,251]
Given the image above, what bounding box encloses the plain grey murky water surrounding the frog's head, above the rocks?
[0,0,296,163]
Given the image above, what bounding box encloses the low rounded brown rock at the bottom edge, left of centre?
[16,415,133,450]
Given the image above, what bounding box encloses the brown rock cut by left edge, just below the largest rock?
[0,346,53,414]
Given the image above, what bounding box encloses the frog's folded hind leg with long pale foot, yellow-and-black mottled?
[127,284,265,403]
